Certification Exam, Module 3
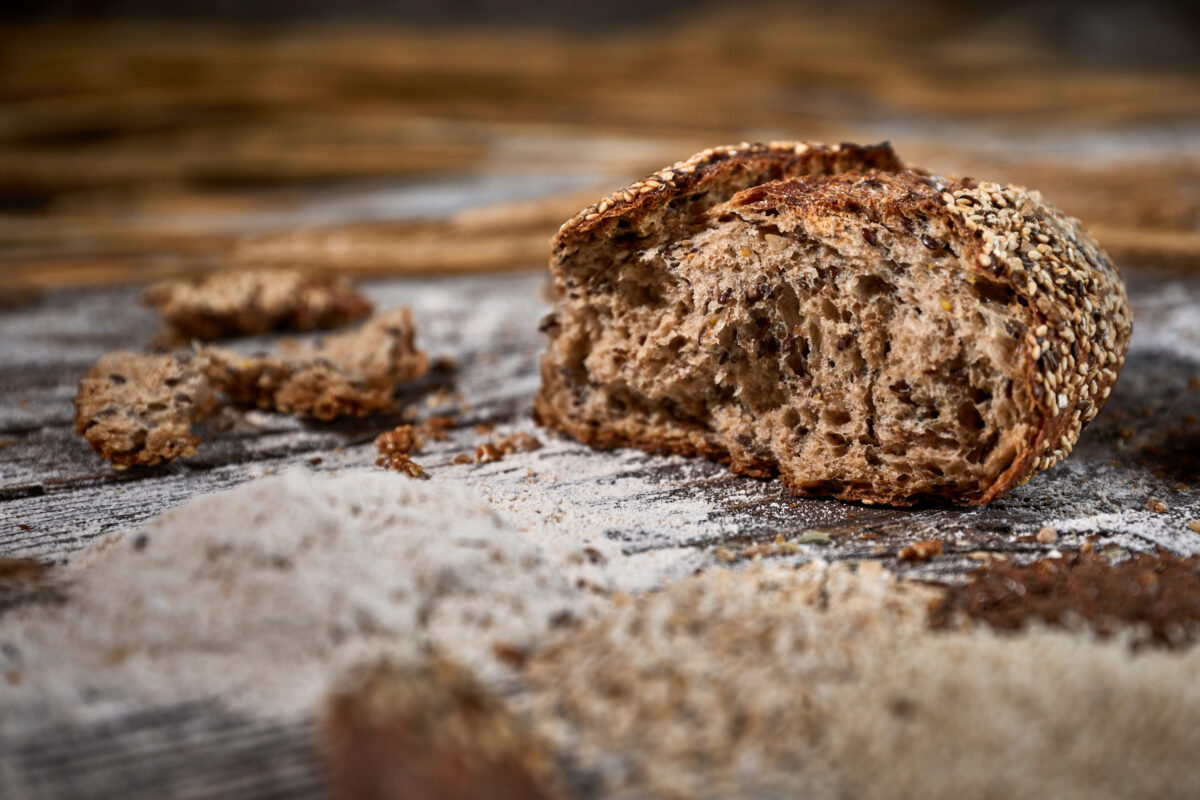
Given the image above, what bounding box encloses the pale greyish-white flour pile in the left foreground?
[0,470,607,717]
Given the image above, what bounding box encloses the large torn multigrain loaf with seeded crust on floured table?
[535,143,1130,505]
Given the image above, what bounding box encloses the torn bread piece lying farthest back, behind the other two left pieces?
[144,270,372,343]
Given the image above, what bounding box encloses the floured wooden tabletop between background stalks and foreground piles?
[0,272,1200,571]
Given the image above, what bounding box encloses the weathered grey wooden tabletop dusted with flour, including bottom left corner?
[0,267,1200,796]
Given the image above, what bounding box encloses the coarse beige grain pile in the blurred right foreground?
[523,563,1200,800]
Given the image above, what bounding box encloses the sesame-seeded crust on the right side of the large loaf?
[730,169,1132,505]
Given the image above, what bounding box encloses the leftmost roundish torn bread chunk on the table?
[74,353,217,469]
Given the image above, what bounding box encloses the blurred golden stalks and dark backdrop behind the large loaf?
[0,0,1200,291]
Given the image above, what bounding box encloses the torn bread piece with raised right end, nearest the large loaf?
[199,308,428,420]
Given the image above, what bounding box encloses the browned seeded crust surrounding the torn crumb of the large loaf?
[534,143,1132,506]
